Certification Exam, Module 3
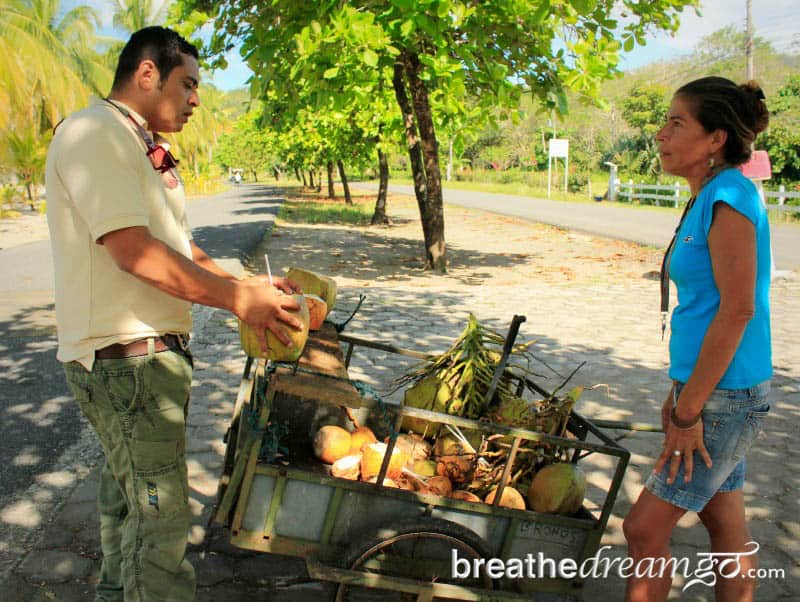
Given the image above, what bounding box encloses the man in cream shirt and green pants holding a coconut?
[46,27,300,602]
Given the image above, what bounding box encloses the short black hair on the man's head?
[113,26,200,89]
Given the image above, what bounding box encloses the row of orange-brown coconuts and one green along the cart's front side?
[314,425,586,515]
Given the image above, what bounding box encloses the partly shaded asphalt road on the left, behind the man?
[0,185,281,511]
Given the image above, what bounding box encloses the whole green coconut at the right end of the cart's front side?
[528,462,586,515]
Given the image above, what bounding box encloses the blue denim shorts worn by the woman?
[644,381,769,512]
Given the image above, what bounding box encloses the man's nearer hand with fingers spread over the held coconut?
[234,278,302,352]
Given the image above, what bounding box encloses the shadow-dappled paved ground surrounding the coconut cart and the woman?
[0,199,800,601]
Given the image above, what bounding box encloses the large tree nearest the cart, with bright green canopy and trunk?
[181,0,696,270]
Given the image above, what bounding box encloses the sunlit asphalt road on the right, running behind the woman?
[353,183,800,270]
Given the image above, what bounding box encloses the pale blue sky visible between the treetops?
[72,0,800,90]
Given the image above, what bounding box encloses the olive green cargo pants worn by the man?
[64,348,195,602]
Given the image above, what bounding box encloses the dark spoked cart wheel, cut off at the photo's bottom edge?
[336,518,494,602]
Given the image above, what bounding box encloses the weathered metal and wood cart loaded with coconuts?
[214,323,629,602]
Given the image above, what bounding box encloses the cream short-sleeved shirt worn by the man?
[45,99,192,370]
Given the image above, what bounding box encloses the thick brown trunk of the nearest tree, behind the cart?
[403,52,447,272]
